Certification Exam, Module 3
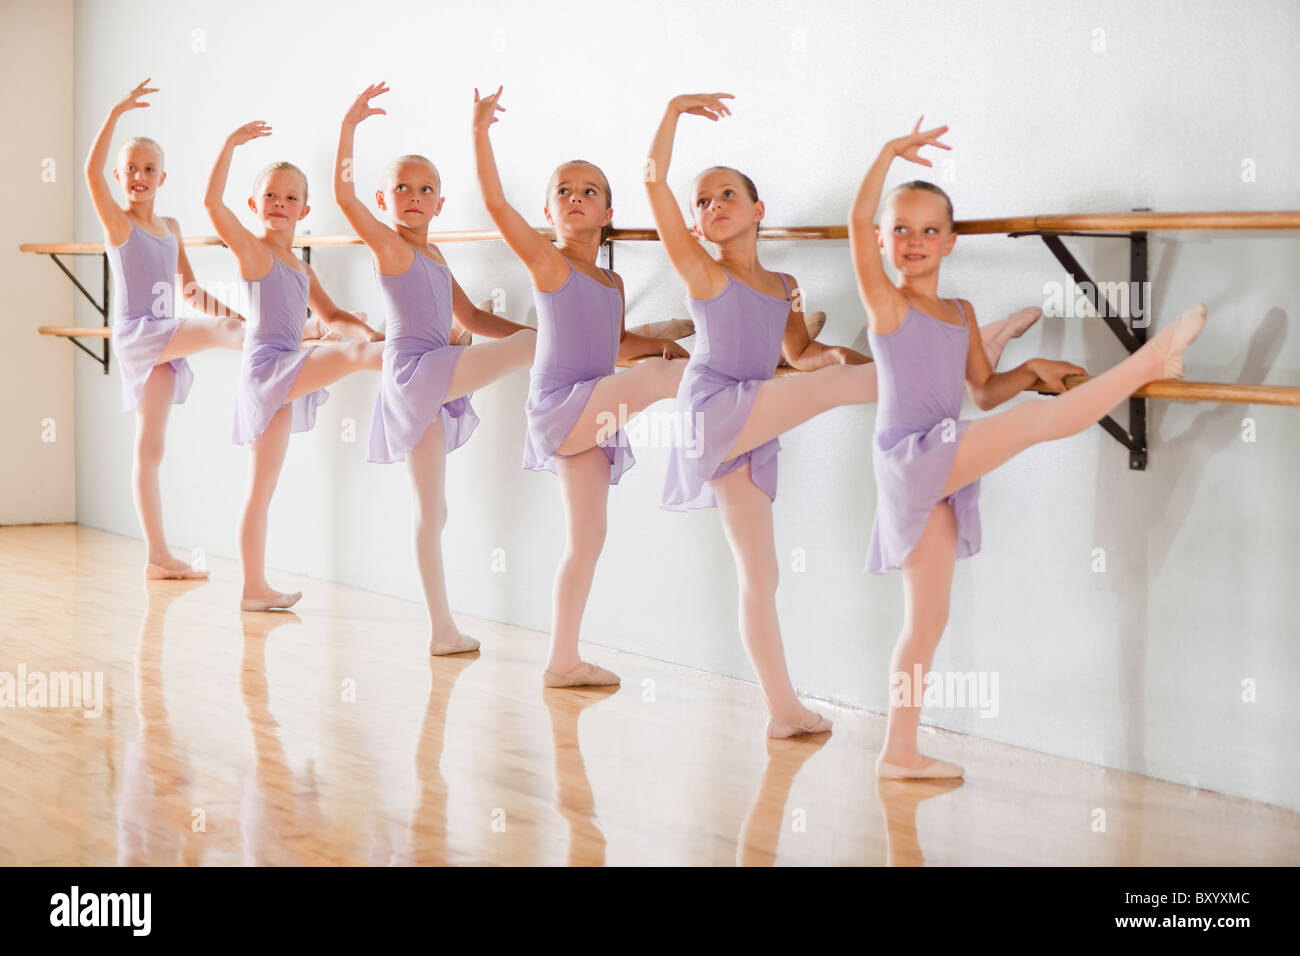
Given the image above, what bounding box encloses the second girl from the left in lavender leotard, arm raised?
[203,121,384,611]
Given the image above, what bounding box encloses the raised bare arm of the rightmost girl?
[849,117,952,334]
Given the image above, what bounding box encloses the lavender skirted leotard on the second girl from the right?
[663,273,790,511]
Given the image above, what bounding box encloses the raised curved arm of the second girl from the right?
[645,92,735,299]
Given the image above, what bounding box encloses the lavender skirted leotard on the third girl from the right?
[524,265,637,485]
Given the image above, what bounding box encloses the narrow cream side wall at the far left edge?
[0,0,74,524]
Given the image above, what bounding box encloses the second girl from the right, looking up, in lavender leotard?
[646,94,875,737]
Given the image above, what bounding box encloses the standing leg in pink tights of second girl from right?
[709,463,831,736]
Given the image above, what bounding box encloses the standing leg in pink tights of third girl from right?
[546,447,619,685]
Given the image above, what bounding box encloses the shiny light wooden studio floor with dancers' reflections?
[0,525,1300,866]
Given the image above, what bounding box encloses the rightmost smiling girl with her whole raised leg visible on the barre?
[849,121,1205,779]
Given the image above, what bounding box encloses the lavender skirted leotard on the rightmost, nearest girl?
[863,302,980,574]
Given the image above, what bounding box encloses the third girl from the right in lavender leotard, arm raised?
[475,87,686,687]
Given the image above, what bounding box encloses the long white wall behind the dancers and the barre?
[49,0,1300,808]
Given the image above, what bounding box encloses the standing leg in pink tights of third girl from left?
[407,415,478,657]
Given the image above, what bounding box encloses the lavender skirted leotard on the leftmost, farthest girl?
[104,222,194,411]
